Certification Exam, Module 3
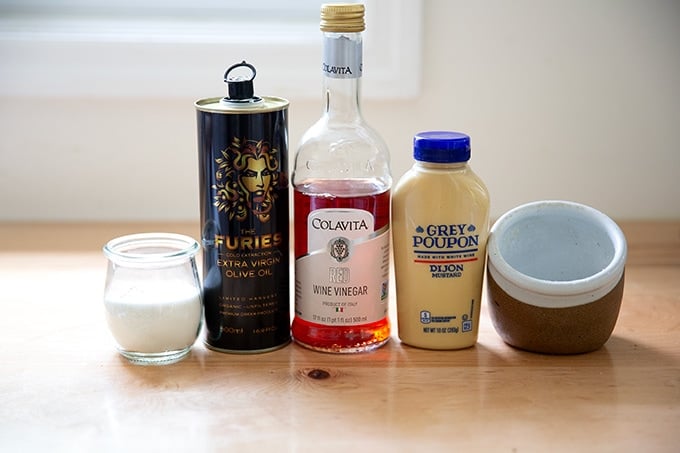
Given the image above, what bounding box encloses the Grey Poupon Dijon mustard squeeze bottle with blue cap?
[392,131,489,349]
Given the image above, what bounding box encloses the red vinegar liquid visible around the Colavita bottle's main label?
[292,180,390,352]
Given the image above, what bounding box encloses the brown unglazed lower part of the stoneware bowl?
[487,272,624,354]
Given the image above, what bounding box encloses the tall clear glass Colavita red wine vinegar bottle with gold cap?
[292,4,392,353]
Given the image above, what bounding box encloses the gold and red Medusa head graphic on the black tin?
[212,137,281,223]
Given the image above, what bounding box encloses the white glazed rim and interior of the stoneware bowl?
[488,201,627,308]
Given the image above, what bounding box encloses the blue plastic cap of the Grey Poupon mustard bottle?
[413,131,470,164]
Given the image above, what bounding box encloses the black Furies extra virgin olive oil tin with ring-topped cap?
[195,61,290,353]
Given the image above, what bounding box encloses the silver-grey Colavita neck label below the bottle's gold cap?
[321,36,363,79]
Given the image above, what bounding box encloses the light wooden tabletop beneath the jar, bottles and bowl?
[0,225,680,453]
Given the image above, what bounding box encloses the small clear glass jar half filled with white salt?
[103,233,203,365]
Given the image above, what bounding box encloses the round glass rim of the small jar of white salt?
[102,232,200,264]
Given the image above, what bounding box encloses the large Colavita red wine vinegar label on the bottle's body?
[295,209,389,326]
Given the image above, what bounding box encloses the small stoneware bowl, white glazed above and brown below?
[487,201,627,354]
